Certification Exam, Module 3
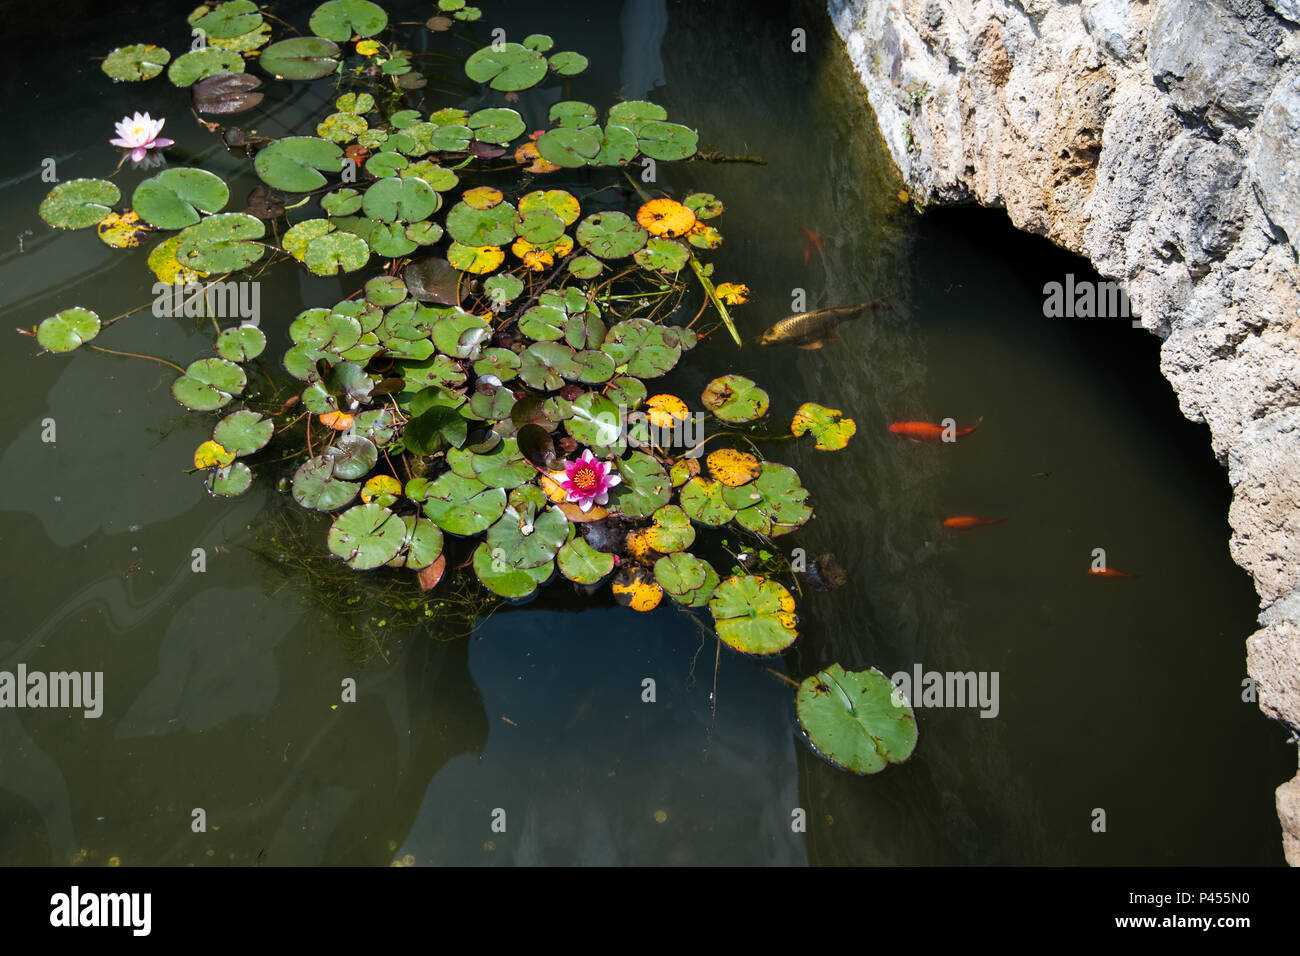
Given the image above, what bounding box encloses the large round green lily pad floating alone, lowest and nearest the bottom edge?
[796,663,917,774]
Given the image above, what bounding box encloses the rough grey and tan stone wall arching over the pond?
[829,0,1300,865]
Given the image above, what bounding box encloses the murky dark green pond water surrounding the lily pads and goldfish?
[0,0,1294,865]
